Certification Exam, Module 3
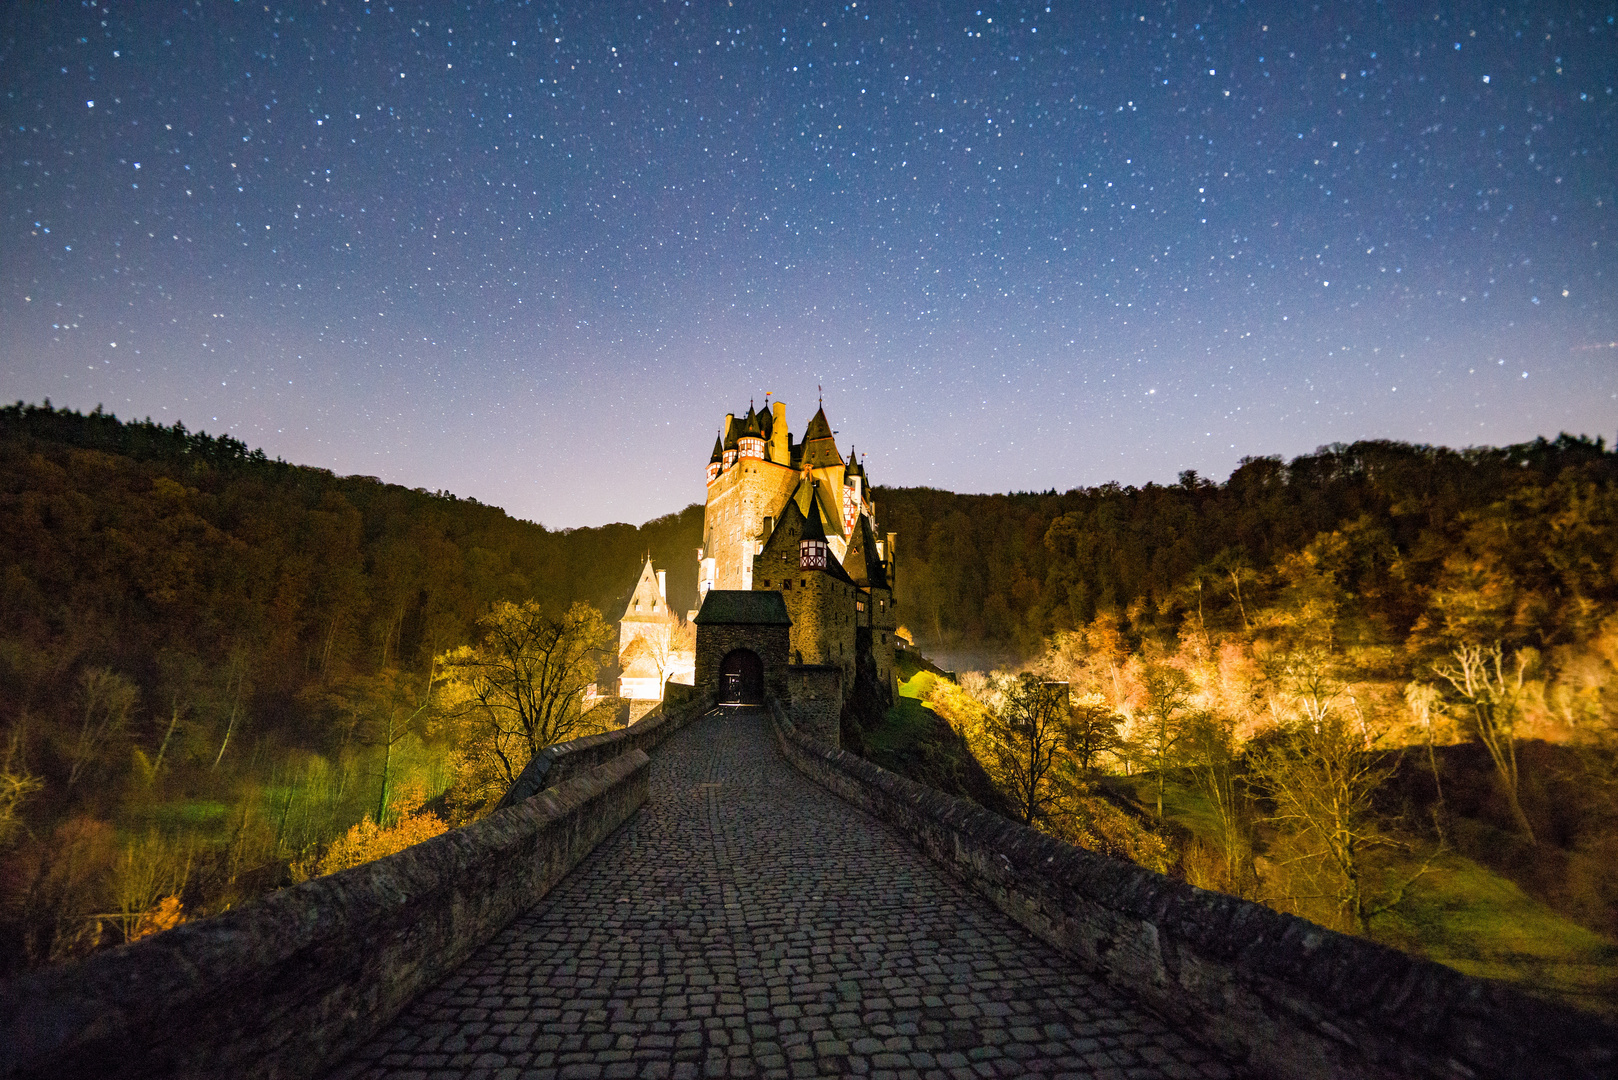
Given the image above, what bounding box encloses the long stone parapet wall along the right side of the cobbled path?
[770,701,1618,1080]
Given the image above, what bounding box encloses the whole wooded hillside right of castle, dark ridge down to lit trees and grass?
[879,436,1618,1010]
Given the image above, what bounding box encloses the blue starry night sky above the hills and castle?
[0,0,1618,526]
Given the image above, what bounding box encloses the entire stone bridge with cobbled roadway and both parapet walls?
[0,701,1618,1080]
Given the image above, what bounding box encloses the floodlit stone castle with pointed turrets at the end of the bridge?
[621,402,896,725]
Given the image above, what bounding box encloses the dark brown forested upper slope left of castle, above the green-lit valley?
[0,402,702,751]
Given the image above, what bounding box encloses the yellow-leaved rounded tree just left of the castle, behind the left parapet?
[438,601,612,785]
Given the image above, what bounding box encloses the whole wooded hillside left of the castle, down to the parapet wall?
[0,403,701,970]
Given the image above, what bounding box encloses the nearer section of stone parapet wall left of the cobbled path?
[0,750,649,1078]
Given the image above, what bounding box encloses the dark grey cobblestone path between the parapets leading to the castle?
[335,711,1231,1080]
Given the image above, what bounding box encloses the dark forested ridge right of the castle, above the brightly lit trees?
[875,436,1618,661]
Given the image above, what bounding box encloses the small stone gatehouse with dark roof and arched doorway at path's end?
[694,589,793,704]
